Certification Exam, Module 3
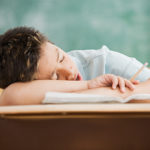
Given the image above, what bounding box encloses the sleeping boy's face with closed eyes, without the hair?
[36,42,82,80]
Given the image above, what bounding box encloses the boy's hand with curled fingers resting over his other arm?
[88,74,139,93]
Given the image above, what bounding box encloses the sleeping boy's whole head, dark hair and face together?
[0,27,82,88]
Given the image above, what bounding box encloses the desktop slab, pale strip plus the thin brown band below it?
[0,103,150,119]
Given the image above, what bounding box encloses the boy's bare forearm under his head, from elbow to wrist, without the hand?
[0,80,88,105]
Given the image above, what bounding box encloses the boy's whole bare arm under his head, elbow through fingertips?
[0,74,136,105]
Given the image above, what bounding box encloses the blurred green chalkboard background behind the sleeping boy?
[0,0,150,63]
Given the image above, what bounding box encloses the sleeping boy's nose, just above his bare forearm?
[58,66,74,80]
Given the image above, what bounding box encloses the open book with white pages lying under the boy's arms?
[42,92,150,104]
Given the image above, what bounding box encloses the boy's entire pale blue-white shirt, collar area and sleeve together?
[68,46,150,81]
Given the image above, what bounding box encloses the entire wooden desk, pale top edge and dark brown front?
[0,104,150,150]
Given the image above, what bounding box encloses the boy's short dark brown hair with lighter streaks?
[0,27,48,88]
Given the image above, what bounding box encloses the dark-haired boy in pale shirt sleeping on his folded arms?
[0,27,150,104]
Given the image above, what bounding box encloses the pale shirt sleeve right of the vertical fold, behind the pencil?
[103,46,150,81]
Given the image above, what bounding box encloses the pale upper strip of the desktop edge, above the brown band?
[0,103,150,114]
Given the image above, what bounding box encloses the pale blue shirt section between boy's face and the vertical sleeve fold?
[68,49,106,80]
